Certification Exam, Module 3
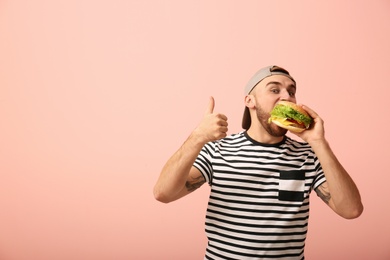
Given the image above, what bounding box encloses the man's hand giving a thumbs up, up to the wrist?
[193,97,228,143]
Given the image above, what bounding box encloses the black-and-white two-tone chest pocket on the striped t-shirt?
[279,171,305,201]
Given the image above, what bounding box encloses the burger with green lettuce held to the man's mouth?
[268,100,313,133]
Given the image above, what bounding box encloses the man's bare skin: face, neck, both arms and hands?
[154,75,363,219]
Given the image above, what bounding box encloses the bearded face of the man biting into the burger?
[251,75,296,137]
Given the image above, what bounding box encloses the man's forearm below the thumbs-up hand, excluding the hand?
[153,133,205,202]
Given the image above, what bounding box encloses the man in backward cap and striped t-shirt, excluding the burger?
[154,66,363,259]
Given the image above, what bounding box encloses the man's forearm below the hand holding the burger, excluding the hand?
[311,139,363,218]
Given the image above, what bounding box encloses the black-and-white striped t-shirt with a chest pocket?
[194,131,326,259]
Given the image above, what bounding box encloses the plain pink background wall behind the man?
[0,0,390,260]
